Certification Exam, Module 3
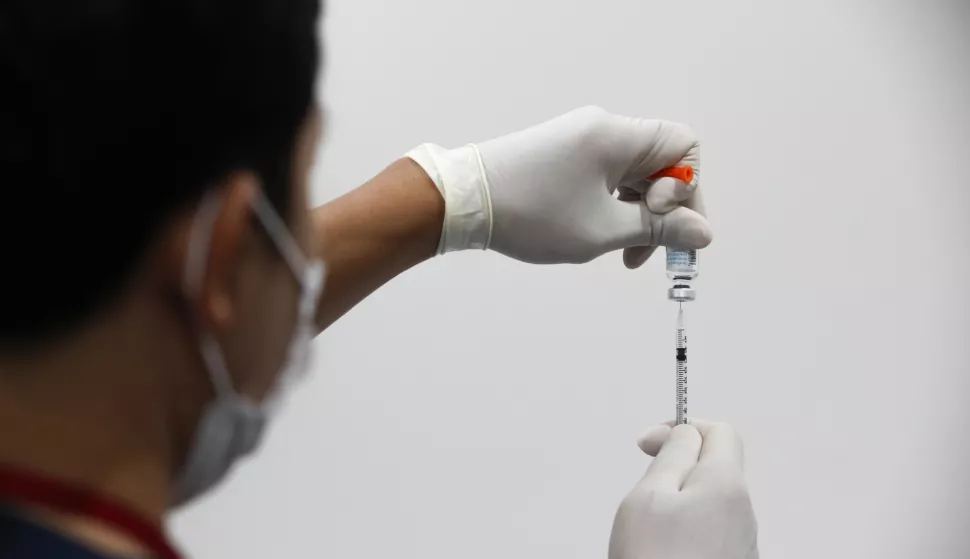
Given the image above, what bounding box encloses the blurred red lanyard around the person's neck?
[0,464,182,559]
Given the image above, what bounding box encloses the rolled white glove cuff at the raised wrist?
[407,144,492,254]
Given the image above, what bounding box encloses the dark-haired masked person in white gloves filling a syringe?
[0,0,758,559]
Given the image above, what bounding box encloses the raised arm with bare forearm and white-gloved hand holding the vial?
[314,107,711,329]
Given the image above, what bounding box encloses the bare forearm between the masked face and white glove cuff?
[313,159,445,330]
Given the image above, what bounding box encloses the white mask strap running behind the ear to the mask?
[182,189,235,396]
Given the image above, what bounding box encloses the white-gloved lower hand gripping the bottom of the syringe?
[609,419,758,559]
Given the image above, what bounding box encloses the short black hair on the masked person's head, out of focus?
[0,0,319,351]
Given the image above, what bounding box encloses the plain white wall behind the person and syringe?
[176,0,970,559]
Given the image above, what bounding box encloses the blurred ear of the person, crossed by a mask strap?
[164,171,260,332]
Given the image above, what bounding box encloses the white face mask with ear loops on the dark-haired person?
[173,188,323,506]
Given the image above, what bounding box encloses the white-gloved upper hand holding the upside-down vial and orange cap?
[408,107,711,268]
